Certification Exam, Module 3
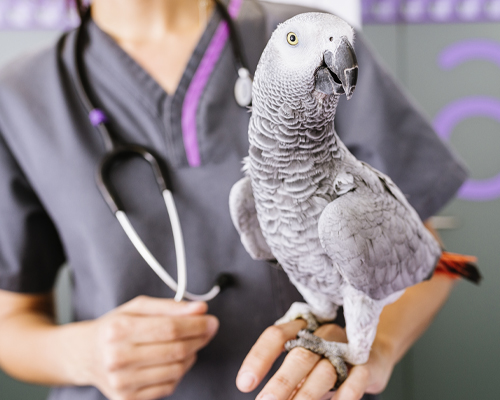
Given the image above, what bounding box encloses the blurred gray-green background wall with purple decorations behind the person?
[0,0,500,400]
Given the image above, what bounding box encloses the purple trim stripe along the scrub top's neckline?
[182,0,243,167]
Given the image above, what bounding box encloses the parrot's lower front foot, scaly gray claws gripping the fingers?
[285,329,348,390]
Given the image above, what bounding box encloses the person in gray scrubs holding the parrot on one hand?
[0,0,465,400]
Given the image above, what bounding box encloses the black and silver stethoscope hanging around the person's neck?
[72,0,252,301]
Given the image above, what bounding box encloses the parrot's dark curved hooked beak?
[315,36,358,100]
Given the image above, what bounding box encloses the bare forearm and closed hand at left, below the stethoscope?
[0,290,218,400]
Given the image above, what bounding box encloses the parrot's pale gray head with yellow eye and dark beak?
[254,13,358,112]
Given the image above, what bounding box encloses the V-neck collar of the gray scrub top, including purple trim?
[86,0,243,167]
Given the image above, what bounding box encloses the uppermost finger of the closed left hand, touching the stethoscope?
[120,296,208,316]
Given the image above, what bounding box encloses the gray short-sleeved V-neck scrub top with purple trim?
[0,0,465,400]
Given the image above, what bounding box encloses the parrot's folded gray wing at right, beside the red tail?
[318,163,441,300]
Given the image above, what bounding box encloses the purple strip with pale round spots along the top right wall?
[362,0,500,24]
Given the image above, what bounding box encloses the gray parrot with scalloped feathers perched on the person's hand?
[229,13,478,384]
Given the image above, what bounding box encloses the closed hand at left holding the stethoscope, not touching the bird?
[81,296,219,400]
